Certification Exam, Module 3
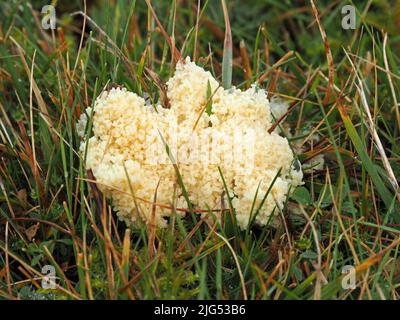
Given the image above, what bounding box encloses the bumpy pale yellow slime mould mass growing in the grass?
[78,58,303,228]
